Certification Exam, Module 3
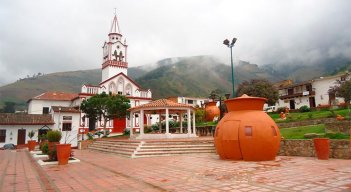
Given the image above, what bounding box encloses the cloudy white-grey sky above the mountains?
[0,0,351,85]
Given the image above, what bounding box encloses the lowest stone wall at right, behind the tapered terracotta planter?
[278,139,351,159]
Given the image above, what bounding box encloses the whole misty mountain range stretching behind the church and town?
[0,56,351,109]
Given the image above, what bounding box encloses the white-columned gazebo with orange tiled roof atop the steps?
[128,99,197,139]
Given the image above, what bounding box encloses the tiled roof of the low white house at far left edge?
[0,113,55,125]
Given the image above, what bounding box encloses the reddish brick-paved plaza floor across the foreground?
[0,150,351,192]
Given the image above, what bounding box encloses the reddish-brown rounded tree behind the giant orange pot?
[236,79,279,105]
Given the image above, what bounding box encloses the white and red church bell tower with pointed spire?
[102,14,128,82]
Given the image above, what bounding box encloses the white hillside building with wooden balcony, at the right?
[276,74,348,109]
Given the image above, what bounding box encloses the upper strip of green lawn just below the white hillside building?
[268,109,349,123]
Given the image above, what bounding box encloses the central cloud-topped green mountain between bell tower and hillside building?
[136,56,278,98]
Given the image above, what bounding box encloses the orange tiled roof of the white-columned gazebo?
[128,99,194,111]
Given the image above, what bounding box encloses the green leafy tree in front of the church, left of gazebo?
[80,92,130,134]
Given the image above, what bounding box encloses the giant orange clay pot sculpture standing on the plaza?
[215,95,280,161]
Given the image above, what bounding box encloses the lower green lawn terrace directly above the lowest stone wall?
[280,124,350,139]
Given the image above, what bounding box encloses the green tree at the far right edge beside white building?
[328,75,351,106]
